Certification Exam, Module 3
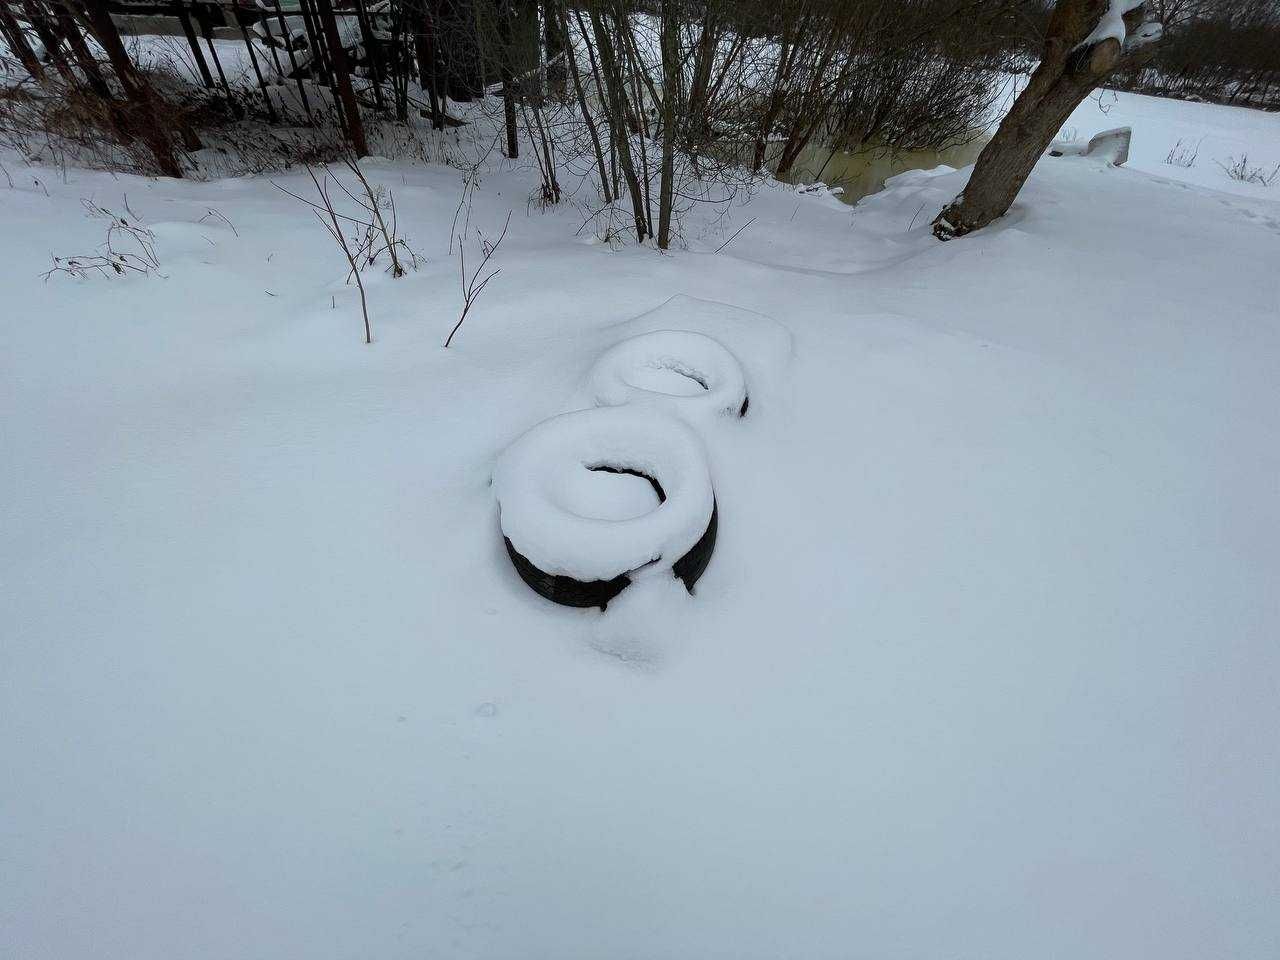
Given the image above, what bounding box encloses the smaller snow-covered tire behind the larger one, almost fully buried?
[588,330,749,417]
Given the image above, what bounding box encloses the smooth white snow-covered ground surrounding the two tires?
[0,86,1280,960]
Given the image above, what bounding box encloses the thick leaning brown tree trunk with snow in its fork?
[933,0,1160,241]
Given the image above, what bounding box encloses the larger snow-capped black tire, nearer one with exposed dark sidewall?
[494,406,718,609]
